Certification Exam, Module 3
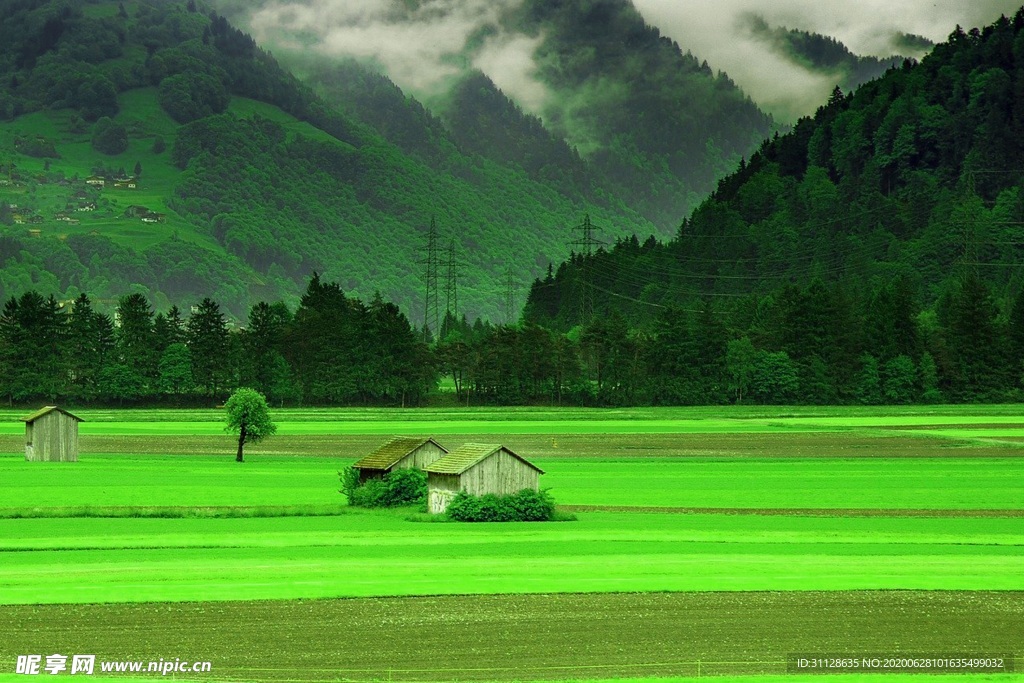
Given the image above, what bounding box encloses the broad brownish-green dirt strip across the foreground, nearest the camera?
[0,579,1024,681]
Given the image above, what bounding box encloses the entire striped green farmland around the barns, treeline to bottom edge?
[0,407,1024,683]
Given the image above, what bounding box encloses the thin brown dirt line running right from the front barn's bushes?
[558,505,1024,517]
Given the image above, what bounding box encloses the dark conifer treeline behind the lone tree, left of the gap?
[0,275,436,404]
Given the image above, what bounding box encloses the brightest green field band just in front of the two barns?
[0,512,1024,604]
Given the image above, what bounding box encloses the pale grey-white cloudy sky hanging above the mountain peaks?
[235,0,1022,123]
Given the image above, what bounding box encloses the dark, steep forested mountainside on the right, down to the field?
[525,9,1024,402]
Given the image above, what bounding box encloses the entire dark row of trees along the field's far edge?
[0,266,1024,405]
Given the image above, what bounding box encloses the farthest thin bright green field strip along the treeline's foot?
[0,404,1024,434]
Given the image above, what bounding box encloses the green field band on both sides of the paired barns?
[0,454,1024,517]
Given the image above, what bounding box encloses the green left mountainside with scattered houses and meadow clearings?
[0,0,657,327]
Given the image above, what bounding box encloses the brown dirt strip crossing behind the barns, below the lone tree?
[0,431,1024,459]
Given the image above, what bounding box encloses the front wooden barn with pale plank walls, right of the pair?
[424,443,544,513]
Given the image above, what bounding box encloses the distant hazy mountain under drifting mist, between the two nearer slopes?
[218,0,775,232]
